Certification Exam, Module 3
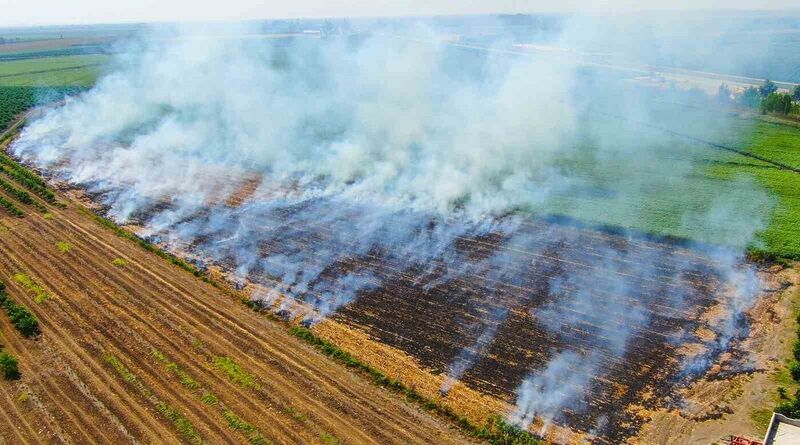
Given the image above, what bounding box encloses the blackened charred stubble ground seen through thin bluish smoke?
[111,200,736,444]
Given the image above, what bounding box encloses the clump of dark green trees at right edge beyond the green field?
[717,79,800,115]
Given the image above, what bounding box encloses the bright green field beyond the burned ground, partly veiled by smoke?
[527,105,800,259]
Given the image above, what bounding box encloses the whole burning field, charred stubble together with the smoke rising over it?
[10,20,792,444]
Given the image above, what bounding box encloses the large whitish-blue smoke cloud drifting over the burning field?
[12,14,769,440]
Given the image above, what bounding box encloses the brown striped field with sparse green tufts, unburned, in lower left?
[0,188,476,443]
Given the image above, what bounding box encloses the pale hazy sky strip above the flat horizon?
[0,0,800,26]
